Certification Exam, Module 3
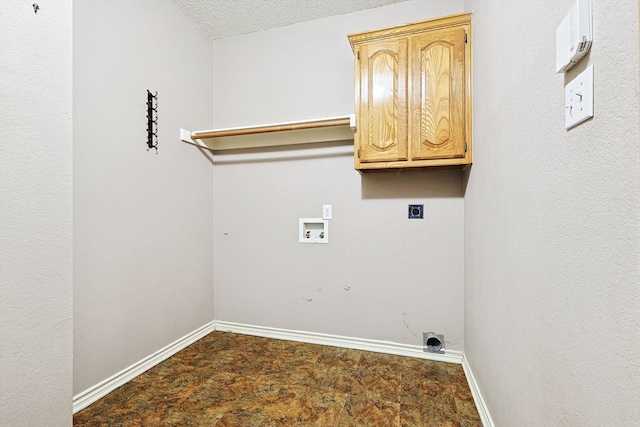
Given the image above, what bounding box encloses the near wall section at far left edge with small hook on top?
[0,0,73,426]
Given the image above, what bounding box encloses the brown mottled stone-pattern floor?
[73,332,482,427]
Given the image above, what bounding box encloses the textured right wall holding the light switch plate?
[464,0,640,426]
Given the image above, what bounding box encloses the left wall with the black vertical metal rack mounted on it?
[73,0,214,394]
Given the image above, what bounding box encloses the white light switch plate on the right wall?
[564,65,593,130]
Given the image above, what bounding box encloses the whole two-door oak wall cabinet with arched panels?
[349,14,471,172]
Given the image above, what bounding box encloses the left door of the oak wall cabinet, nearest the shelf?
[356,38,408,162]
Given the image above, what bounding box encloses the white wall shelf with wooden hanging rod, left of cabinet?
[180,114,356,151]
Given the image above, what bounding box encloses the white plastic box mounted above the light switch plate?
[556,0,593,73]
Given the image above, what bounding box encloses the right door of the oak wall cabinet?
[409,27,467,160]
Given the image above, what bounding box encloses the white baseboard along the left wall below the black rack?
[73,320,216,414]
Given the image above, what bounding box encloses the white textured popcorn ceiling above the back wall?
[171,0,405,39]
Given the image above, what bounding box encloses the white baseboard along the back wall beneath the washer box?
[216,320,463,364]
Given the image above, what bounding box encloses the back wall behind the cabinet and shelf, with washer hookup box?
[214,1,464,350]
